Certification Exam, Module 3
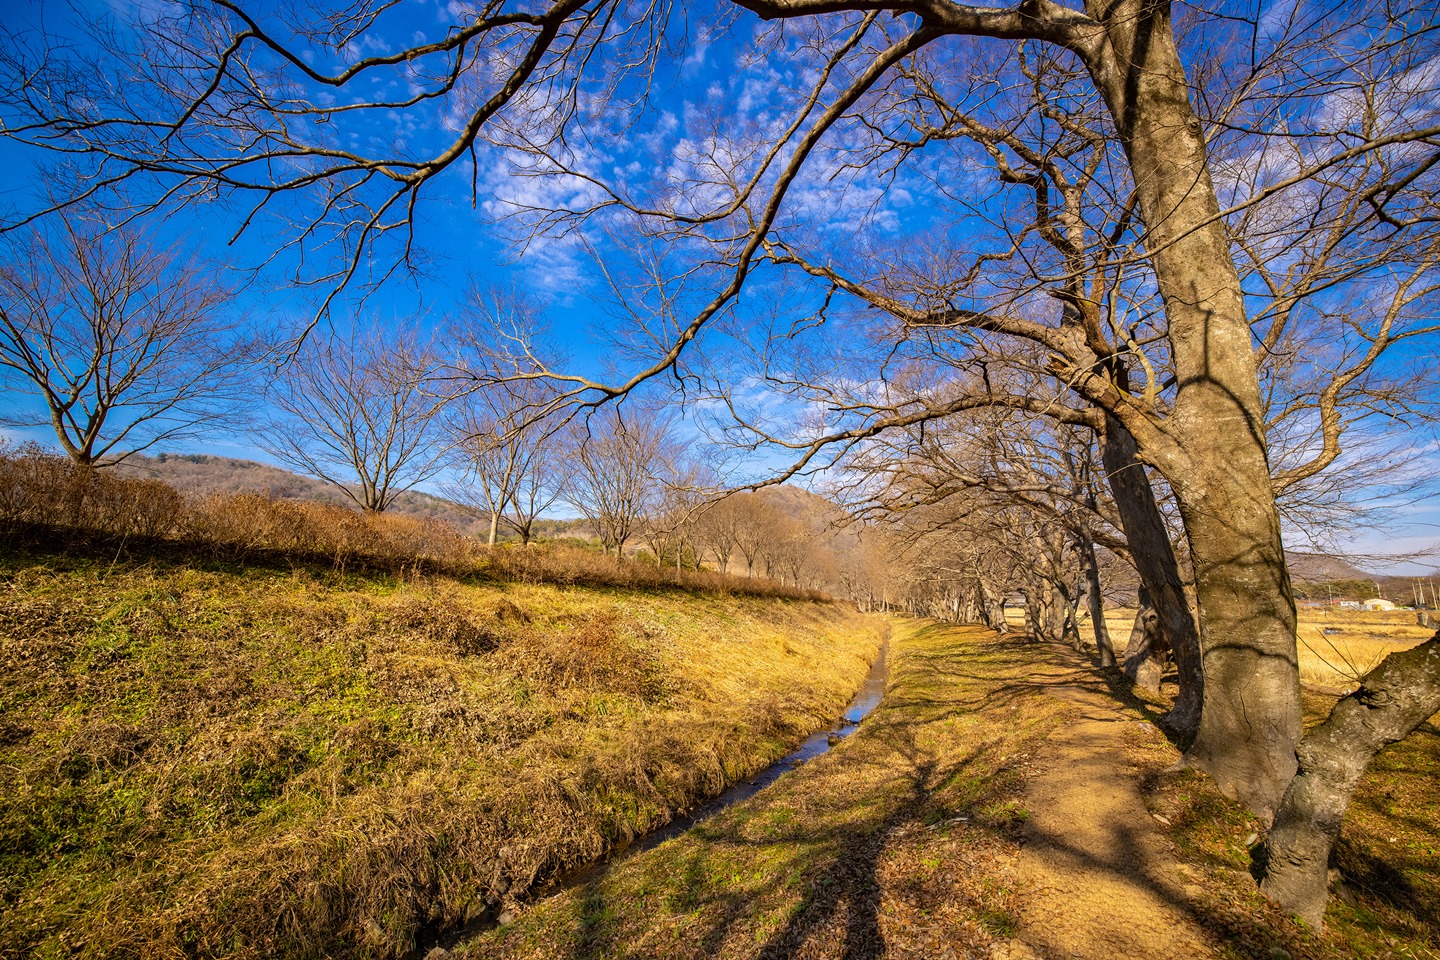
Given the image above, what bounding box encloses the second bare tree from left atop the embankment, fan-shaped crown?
[264,325,445,512]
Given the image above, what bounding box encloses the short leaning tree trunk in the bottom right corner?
[1260,633,1440,925]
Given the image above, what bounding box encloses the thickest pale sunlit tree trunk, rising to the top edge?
[1076,0,1300,816]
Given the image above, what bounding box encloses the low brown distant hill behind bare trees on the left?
[115,453,583,537]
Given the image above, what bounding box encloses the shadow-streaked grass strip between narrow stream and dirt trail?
[461,622,1082,960]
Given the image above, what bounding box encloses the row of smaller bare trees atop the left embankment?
[0,207,869,587]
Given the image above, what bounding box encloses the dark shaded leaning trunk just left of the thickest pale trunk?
[1100,416,1205,738]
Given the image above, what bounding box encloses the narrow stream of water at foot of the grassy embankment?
[415,640,890,957]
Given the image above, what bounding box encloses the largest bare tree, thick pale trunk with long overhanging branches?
[0,0,1440,921]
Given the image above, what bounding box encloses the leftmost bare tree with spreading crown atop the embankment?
[0,210,256,466]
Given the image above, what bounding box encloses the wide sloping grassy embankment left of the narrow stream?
[0,541,883,957]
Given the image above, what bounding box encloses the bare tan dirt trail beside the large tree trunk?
[996,653,1215,960]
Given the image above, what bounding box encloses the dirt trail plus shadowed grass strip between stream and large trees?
[455,622,1214,960]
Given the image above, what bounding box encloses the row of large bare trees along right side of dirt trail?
[0,0,1440,920]
